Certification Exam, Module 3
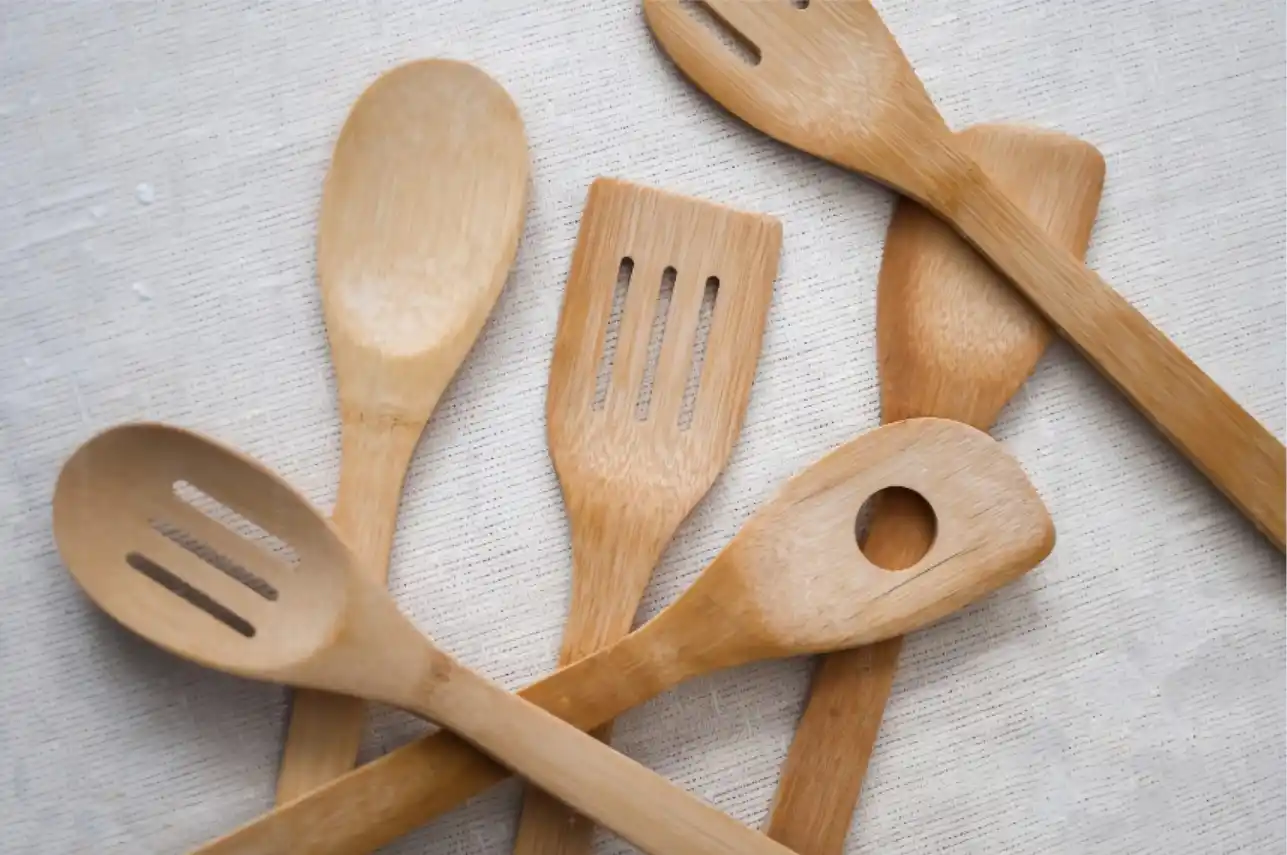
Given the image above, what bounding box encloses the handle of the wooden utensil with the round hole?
[193,619,705,855]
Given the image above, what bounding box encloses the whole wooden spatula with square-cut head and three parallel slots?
[515,179,782,855]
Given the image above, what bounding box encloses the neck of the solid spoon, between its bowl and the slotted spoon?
[332,408,423,571]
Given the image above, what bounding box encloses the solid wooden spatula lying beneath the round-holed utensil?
[768,125,1104,855]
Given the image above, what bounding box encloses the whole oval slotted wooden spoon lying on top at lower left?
[54,425,792,855]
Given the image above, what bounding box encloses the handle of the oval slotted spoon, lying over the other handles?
[432,668,790,855]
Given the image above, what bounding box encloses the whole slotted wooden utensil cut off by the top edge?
[644,0,1287,550]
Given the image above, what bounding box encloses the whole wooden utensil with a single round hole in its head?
[190,418,1054,855]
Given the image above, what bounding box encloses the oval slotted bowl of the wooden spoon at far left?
[54,424,349,679]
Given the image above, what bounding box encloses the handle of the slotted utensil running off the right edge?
[938,160,1287,550]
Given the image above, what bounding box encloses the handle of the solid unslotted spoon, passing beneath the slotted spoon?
[277,413,421,805]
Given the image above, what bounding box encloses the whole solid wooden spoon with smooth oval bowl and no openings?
[277,59,528,802]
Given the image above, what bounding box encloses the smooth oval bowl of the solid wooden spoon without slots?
[318,59,529,396]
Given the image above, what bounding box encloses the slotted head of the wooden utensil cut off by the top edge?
[644,0,951,198]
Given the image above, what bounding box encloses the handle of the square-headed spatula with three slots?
[514,527,669,855]
